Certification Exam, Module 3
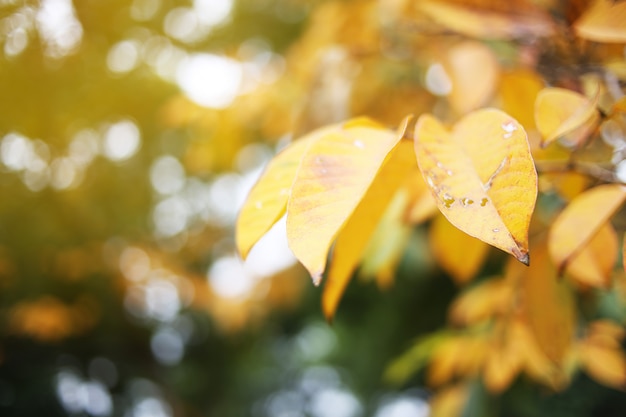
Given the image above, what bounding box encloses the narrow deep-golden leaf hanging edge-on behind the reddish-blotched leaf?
[322,140,417,320]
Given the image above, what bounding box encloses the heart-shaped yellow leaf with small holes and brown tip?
[415,109,537,264]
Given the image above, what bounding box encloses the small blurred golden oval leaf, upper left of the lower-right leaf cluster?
[450,278,512,325]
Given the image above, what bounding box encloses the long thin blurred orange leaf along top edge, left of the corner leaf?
[417,0,552,39]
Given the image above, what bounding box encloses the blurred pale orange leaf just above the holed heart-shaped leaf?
[444,41,500,114]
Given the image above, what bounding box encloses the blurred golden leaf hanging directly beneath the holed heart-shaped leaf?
[429,215,489,284]
